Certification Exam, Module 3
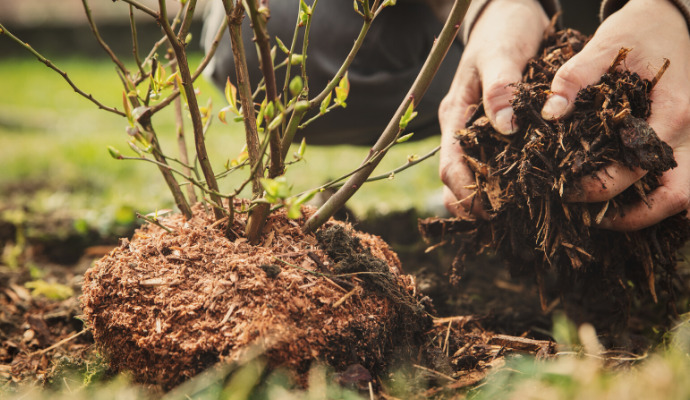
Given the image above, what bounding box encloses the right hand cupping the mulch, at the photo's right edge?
[542,0,690,231]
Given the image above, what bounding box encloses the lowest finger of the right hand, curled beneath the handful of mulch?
[599,153,690,231]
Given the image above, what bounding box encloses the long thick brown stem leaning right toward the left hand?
[302,0,470,232]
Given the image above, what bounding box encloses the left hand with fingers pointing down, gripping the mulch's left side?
[439,0,549,217]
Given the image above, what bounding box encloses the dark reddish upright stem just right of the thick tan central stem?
[246,0,284,178]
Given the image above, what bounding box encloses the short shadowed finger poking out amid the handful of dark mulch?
[564,163,647,203]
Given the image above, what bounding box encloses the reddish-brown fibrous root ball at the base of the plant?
[82,206,431,387]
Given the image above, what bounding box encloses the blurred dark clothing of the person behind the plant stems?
[203,0,462,145]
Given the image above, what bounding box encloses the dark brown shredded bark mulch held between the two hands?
[420,30,690,316]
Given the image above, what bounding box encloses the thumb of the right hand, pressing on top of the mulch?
[541,42,615,120]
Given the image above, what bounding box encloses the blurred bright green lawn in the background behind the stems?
[0,55,441,223]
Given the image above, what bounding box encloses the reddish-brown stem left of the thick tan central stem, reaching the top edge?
[158,0,224,220]
